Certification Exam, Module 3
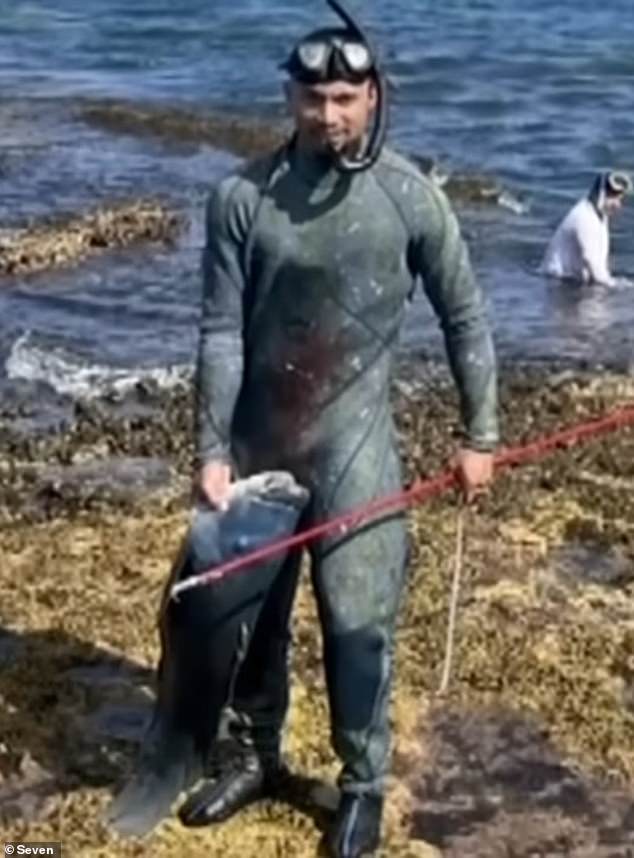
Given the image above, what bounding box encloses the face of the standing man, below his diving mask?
[287,80,376,154]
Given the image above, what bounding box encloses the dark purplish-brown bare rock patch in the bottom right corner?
[404,709,634,858]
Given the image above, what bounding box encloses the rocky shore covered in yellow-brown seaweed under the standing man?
[0,362,634,858]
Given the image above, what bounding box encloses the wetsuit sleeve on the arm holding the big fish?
[195,179,245,464]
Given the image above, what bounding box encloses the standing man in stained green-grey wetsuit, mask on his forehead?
[185,0,498,858]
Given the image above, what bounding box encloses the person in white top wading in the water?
[540,172,632,286]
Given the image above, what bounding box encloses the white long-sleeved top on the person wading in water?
[540,197,614,286]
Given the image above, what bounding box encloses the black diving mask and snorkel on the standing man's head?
[281,0,388,173]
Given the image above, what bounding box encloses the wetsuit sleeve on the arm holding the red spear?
[410,185,498,451]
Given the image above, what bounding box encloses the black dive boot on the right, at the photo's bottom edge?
[324,792,383,858]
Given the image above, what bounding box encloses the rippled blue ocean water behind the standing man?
[0,0,634,402]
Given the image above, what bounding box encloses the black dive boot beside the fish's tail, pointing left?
[178,748,286,826]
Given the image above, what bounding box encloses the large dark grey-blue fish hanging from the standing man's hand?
[107,471,309,836]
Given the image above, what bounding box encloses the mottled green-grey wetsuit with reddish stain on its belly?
[197,142,497,792]
